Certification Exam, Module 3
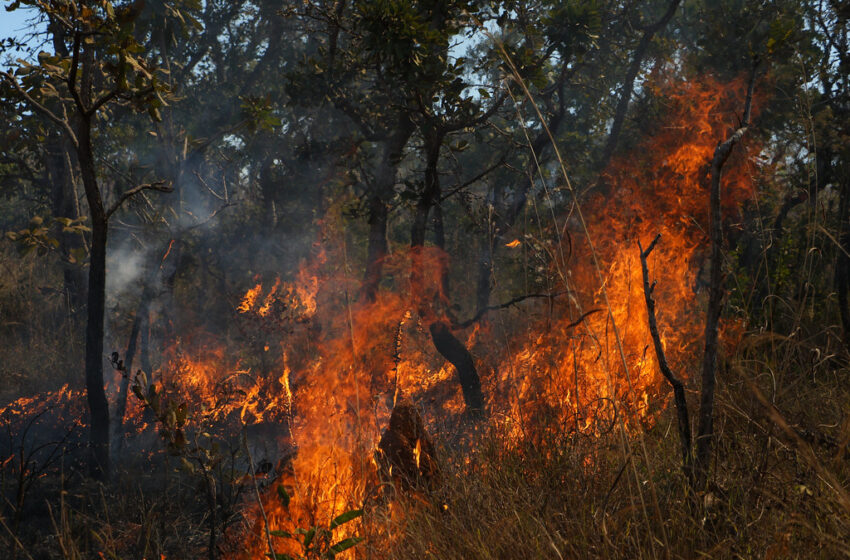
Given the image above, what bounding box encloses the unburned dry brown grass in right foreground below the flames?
[373,341,850,560]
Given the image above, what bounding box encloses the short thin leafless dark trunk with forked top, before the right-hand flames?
[638,233,693,483]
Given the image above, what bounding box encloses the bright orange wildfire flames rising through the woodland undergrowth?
[0,75,752,558]
